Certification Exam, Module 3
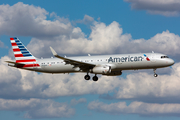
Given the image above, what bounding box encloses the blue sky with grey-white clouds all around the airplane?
[0,0,180,120]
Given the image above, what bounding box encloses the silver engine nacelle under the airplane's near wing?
[91,66,111,74]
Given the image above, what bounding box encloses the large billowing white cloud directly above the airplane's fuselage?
[27,21,180,59]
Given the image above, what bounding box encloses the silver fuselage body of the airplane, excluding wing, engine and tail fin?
[22,53,174,73]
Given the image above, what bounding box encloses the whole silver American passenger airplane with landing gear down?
[6,38,174,81]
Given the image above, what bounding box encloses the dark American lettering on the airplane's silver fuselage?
[108,56,143,63]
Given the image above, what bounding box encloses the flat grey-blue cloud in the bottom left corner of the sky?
[0,98,75,119]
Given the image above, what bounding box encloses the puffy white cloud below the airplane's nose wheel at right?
[115,63,180,103]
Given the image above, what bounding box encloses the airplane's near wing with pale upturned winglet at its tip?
[50,47,96,70]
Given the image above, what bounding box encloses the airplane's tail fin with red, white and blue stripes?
[10,37,36,64]
